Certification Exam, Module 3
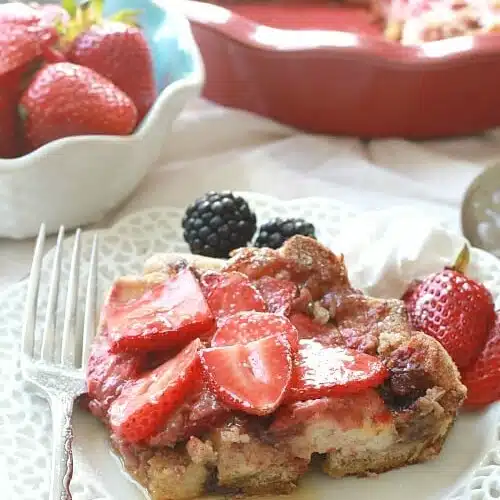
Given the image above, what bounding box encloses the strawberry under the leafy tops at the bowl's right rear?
[67,16,156,121]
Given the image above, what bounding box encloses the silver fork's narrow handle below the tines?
[49,394,74,500]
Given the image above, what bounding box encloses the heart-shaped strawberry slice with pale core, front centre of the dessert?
[200,335,292,415]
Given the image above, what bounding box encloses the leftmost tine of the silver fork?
[22,223,45,356]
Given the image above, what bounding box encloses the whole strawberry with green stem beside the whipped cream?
[403,247,495,368]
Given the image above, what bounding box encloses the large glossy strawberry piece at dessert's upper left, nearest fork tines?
[106,269,214,352]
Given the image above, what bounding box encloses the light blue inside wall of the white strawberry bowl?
[104,0,196,92]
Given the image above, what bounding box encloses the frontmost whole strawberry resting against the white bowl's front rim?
[20,62,137,149]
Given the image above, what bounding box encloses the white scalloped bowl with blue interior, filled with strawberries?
[0,0,203,238]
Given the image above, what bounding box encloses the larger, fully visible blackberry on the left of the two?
[182,191,257,258]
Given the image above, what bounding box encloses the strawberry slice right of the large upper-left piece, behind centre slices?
[200,271,266,319]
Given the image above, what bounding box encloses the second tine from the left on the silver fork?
[41,226,64,363]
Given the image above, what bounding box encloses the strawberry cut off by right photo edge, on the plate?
[462,313,500,407]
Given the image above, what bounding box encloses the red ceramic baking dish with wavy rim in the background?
[182,1,500,139]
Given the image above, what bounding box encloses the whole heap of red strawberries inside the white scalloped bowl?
[0,0,156,158]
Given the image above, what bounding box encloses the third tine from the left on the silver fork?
[61,229,81,366]
